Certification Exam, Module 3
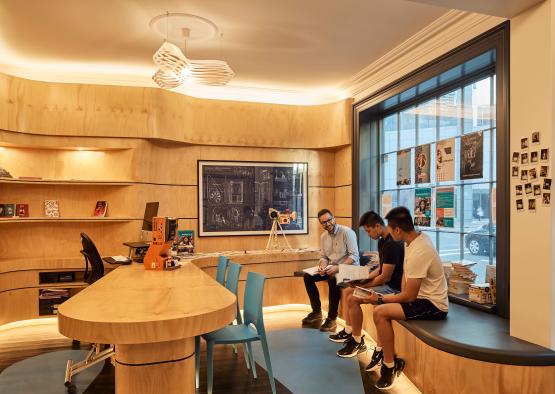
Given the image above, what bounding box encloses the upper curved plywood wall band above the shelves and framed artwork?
[0,74,352,149]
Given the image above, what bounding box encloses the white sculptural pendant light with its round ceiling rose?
[150,13,235,89]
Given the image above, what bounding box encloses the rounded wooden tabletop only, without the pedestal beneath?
[58,262,236,344]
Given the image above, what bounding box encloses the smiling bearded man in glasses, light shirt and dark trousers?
[303,209,359,331]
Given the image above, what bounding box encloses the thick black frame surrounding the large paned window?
[352,21,511,318]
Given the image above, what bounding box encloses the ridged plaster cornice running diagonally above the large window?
[342,10,505,102]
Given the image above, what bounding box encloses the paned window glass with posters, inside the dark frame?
[378,75,496,283]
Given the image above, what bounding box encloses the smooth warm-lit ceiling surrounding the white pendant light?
[0,0,447,103]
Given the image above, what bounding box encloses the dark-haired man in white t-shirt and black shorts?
[367,207,449,388]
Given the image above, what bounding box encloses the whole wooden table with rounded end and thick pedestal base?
[58,262,236,394]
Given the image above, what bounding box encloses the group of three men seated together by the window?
[303,207,449,388]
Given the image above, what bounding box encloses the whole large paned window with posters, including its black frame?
[353,28,509,316]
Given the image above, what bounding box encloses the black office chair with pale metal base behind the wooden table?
[65,233,115,393]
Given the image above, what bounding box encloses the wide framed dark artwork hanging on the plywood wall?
[198,161,308,237]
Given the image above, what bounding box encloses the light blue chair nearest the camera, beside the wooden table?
[200,272,276,394]
